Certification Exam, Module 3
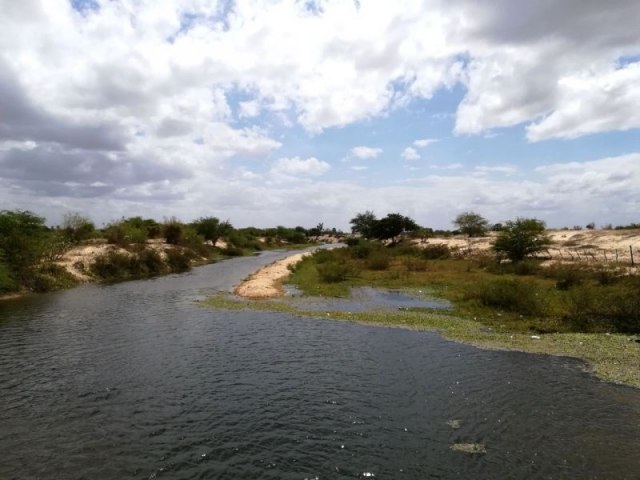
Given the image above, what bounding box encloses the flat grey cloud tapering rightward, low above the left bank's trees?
[0,145,191,197]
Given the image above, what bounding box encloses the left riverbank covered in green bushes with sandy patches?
[0,210,338,293]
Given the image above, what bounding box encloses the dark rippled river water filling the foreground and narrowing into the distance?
[0,252,640,480]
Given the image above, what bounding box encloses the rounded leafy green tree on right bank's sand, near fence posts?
[493,218,551,262]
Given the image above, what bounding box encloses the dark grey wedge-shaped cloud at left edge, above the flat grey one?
[0,61,125,151]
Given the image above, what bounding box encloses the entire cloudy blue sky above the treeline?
[0,0,640,230]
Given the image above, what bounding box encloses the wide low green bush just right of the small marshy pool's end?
[465,278,546,316]
